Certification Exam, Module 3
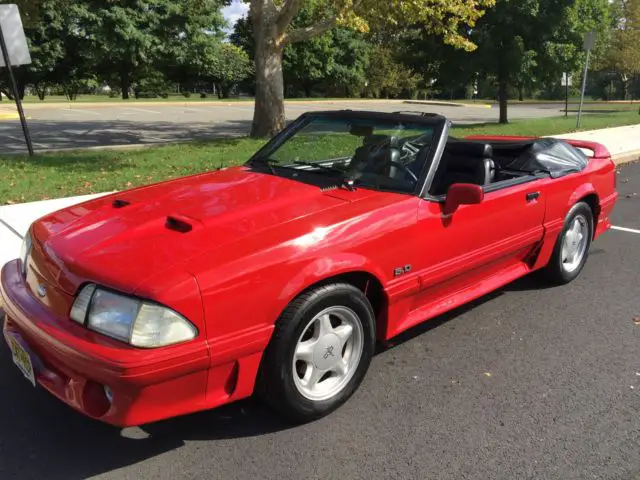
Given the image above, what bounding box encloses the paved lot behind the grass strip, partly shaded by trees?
[0,101,561,153]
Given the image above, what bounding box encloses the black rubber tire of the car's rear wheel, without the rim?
[543,202,594,285]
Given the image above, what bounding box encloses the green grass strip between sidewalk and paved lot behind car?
[0,111,640,205]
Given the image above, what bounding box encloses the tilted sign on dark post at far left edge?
[0,4,33,155]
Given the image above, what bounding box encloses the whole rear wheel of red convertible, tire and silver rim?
[545,202,594,284]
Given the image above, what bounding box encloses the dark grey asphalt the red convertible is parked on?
[0,163,640,480]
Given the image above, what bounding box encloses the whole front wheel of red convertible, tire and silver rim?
[259,283,375,422]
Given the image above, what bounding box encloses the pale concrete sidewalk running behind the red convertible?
[0,124,640,266]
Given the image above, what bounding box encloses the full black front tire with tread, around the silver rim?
[258,283,376,423]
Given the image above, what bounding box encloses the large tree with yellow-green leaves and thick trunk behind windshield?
[250,0,493,137]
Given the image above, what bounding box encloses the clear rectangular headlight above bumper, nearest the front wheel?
[70,284,198,348]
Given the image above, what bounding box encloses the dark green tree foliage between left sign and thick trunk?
[3,0,251,99]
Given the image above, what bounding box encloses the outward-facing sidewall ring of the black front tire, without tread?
[277,285,375,420]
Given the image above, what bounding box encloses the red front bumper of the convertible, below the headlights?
[0,260,211,427]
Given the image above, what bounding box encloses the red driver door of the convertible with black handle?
[414,177,545,320]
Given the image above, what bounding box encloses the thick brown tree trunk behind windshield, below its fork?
[251,38,285,138]
